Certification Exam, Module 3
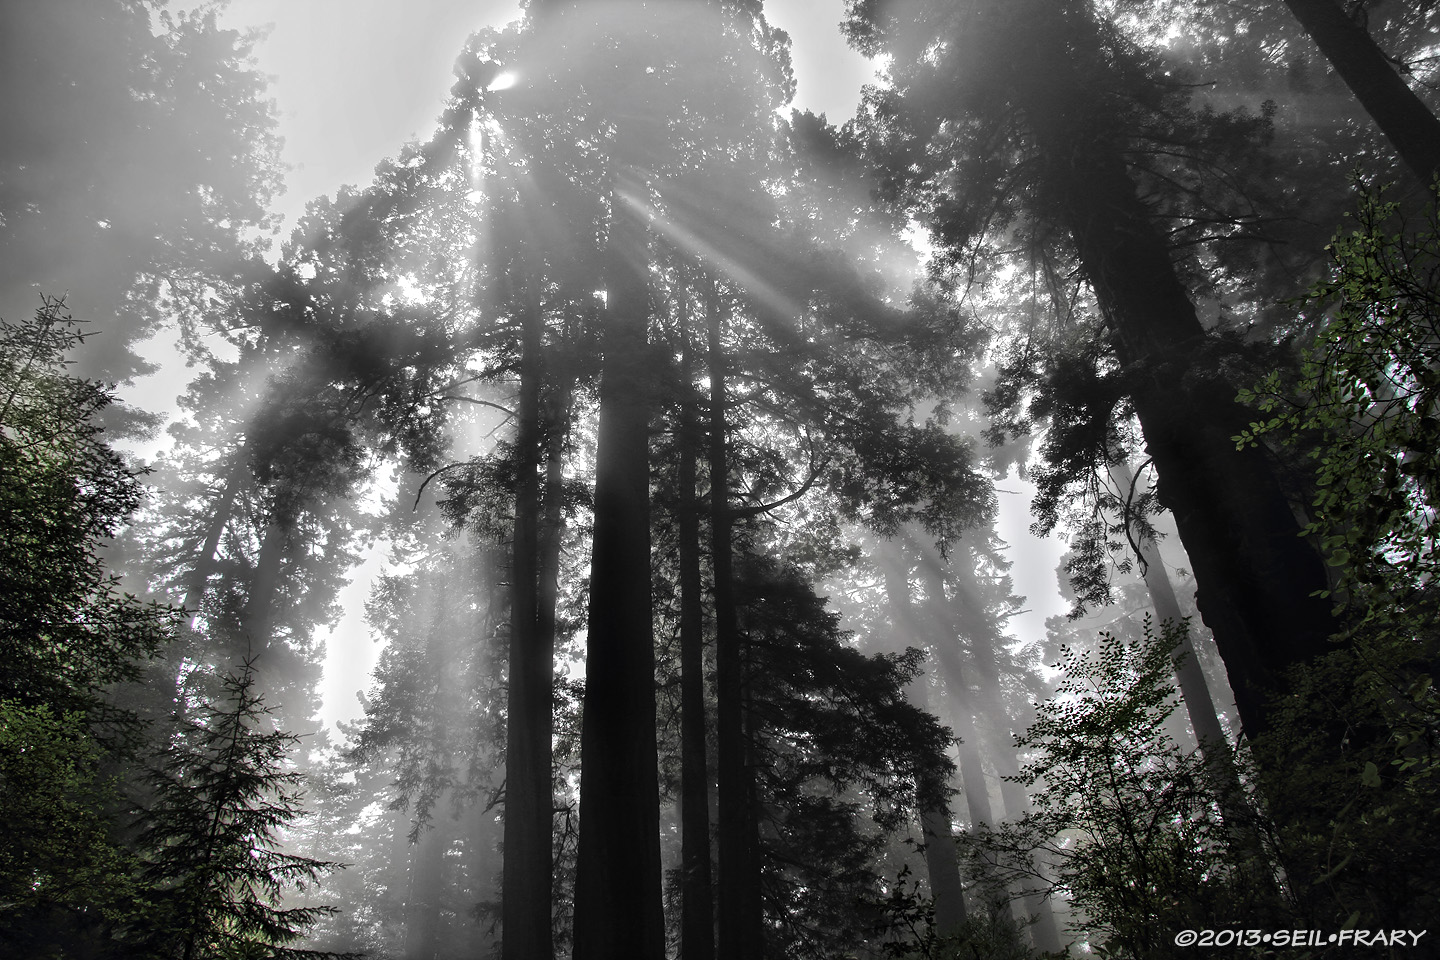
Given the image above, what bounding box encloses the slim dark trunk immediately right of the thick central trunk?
[675,277,716,960]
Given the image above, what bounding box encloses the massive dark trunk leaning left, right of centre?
[1017,0,1335,735]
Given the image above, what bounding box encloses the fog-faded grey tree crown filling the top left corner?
[0,0,281,394]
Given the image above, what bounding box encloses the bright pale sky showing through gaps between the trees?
[208,0,1061,723]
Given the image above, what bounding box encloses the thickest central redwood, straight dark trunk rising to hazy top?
[524,3,675,960]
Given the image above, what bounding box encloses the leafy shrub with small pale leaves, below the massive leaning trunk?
[969,623,1280,957]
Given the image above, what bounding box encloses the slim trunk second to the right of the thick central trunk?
[706,282,765,960]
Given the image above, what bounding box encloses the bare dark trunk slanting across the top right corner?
[1284,0,1440,186]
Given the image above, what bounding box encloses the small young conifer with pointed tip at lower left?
[141,664,357,960]
